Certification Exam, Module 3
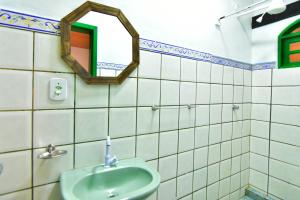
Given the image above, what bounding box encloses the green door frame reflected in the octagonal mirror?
[71,22,98,77]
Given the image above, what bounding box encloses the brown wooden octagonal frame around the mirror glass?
[61,1,140,84]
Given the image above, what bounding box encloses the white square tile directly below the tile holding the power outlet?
[33,110,74,148]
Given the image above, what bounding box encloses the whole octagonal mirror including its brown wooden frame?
[61,1,139,84]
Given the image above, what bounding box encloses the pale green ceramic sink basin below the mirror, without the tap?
[60,158,160,200]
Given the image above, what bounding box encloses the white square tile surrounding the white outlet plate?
[34,72,74,109]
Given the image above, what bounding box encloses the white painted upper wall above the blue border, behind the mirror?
[0,0,252,62]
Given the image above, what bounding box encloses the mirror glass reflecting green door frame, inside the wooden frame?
[70,11,132,77]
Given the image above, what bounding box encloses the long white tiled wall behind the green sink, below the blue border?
[0,28,251,200]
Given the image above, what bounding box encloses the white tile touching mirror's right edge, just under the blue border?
[138,51,161,79]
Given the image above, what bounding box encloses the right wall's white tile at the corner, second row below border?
[252,87,270,104]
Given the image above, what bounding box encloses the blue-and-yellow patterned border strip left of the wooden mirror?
[0,9,60,35]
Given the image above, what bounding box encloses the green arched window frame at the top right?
[278,19,300,69]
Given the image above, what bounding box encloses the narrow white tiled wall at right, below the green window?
[249,68,300,200]
